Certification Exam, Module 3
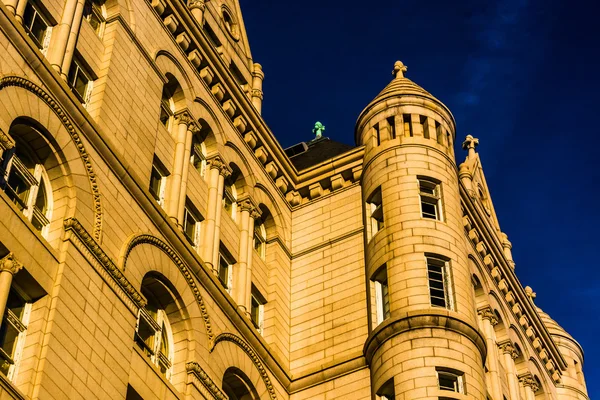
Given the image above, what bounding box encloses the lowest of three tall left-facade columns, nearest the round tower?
[234,197,256,313]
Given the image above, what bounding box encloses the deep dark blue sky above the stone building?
[241,0,600,398]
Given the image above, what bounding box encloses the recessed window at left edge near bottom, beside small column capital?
[0,288,31,381]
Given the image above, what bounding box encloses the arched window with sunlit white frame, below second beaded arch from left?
[134,275,176,379]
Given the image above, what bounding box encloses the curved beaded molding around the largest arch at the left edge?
[0,76,102,240]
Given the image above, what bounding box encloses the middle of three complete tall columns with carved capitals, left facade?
[200,155,231,273]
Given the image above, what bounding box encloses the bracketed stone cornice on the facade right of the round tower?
[459,182,567,383]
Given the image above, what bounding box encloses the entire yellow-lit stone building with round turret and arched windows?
[0,0,588,400]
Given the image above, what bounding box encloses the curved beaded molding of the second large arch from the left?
[121,234,214,340]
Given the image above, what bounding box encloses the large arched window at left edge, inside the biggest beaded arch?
[0,130,52,234]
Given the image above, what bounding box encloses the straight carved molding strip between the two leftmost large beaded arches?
[64,218,146,313]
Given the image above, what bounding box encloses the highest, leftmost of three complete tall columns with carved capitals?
[165,111,192,226]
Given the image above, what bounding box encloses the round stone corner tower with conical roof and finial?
[355,62,486,400]
